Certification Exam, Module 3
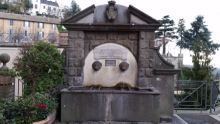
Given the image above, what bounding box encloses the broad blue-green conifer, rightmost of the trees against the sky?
[177,15,220,54]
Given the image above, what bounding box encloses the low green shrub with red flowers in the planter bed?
[0,93,58,124]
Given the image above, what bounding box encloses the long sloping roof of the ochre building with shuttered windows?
[0,12,60,24]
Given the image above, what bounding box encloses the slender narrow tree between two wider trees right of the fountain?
[177,19,185,54]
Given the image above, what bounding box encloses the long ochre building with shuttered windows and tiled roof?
[0,13,60,46]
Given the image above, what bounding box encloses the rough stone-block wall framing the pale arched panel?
[66,31,155,87]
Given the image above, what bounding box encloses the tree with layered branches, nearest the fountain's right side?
[155,15,178,54]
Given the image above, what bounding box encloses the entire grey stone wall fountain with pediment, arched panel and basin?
[61,1,179,124]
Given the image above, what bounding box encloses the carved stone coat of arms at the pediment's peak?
[106,0,118,21]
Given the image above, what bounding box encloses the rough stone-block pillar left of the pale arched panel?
[67,31,84,86]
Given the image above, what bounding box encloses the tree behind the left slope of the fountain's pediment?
[64,0,81,19]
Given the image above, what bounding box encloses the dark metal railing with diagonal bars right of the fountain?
[174,80,220,113]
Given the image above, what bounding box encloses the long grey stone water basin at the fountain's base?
[61,87,160,123]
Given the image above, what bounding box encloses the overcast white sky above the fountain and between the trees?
[57,0,220,67]
